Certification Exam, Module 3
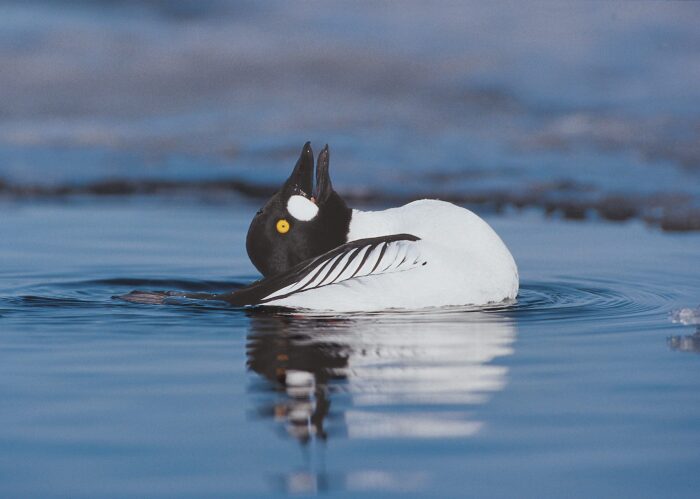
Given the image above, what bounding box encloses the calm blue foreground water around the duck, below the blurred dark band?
[0,199,700,497]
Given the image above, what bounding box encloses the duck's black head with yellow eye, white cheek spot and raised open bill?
[246,142,351,276]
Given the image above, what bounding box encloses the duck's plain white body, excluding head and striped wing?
[268,199,519,312]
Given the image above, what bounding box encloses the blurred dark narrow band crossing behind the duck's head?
[0,178,700,231]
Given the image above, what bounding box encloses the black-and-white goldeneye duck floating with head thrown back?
[217,142,518,311]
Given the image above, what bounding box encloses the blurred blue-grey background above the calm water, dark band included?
[0,0,700,230]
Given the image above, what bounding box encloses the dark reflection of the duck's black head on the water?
[246,311,350,443]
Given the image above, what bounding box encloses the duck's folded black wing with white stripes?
[217,234,427,306]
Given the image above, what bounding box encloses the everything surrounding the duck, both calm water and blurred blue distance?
[0,0,700,498]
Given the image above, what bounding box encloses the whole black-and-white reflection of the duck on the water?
[248,311,515,443]
